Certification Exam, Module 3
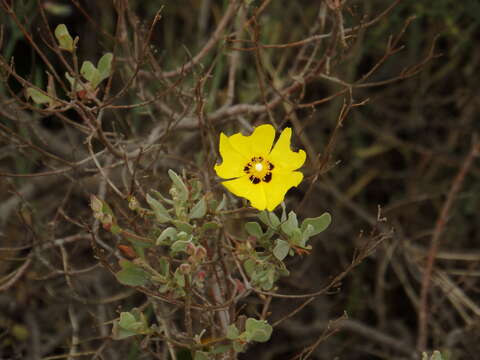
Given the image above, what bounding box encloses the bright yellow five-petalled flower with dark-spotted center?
[215,124,306,211]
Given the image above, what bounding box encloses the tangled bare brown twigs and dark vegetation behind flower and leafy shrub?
[0,0,480,360]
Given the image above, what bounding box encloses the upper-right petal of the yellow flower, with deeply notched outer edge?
[268,128,307,171]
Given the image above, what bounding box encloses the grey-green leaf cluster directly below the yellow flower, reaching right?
[239,208,331,290]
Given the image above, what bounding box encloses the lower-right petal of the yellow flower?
[264,171,303,211]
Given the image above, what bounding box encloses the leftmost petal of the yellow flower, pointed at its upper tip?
[215,133,248,179]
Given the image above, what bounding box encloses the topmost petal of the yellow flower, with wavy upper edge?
[228,124,275,159]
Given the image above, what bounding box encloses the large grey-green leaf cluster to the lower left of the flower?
[91,170,218,298]
